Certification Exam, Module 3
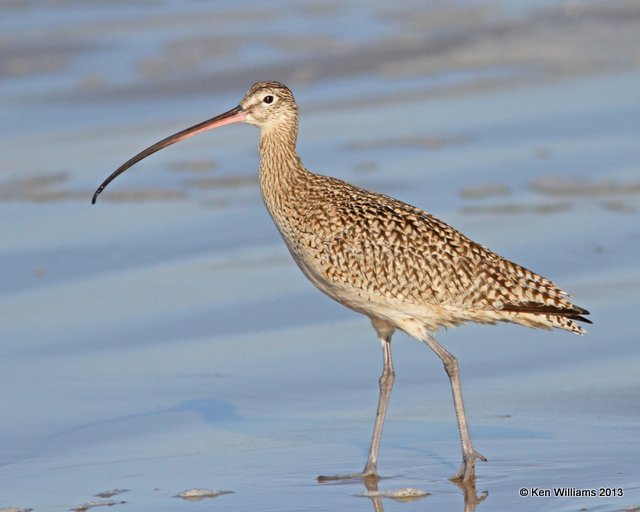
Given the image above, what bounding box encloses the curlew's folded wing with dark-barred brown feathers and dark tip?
[308,183,587,320]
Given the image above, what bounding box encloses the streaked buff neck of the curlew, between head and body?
[260,129,309,218]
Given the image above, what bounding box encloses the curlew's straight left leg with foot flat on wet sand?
[318,331,396,482]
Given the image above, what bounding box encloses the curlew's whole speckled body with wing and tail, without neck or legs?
[272,171,588,335]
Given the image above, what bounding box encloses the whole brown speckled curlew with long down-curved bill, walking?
[92,81,591,483]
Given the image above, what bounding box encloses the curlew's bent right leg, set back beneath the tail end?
[424,336,487,482]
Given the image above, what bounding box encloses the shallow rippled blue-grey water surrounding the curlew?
[0,1,640,511]
